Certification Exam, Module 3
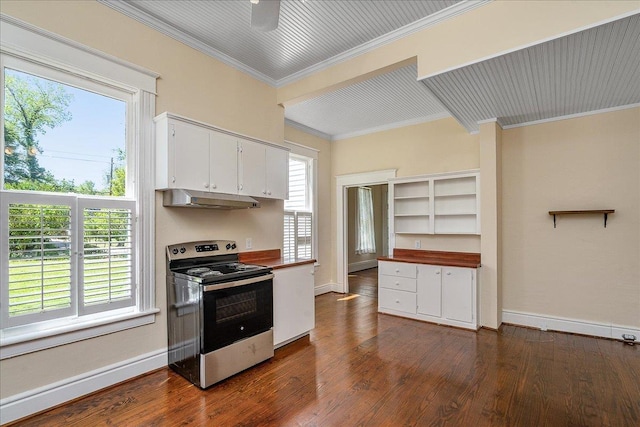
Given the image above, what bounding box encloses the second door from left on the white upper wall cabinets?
[209,131,238,194]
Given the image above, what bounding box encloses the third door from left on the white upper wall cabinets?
[238,140,267,197]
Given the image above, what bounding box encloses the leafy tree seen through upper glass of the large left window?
[4,72,73,183]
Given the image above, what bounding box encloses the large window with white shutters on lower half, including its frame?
[0,22,157,358]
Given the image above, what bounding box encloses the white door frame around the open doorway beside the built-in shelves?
[333,169,397,294]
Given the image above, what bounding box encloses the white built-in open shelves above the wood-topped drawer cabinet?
[389,171,480,241]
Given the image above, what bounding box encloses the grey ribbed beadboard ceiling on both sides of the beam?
[99,0,640,140]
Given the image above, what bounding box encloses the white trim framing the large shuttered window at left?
[0,14,160,359]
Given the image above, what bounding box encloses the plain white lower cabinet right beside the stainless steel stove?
[273,264,315,348]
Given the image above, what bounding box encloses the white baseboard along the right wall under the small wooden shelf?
[502,310,640,340]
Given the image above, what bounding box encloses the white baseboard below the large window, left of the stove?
[0,348,167,424]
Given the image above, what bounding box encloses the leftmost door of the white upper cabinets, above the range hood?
[169,120,209,191]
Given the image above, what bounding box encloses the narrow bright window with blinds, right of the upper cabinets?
[283,154,313,261]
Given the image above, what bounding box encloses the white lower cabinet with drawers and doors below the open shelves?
[378,261,479,330]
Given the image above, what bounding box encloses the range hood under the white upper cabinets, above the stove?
[162,190,260,209]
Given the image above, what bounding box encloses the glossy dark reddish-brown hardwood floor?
[13,274,640,427]
